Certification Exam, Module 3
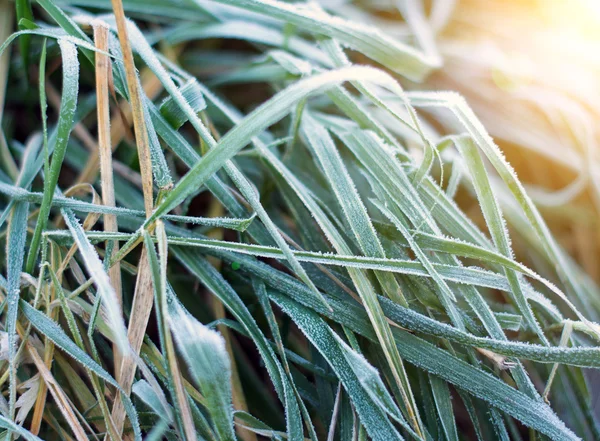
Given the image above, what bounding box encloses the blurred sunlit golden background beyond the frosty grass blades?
[426,0,600,281]
